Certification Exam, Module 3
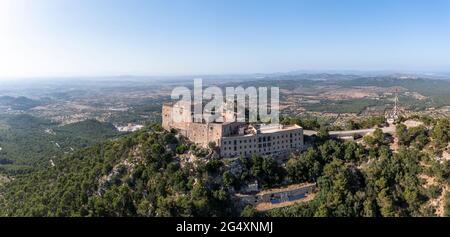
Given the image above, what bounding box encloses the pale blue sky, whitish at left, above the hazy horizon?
[0,0,450,77]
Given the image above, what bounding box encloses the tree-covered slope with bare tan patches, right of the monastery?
[266,118,450,217]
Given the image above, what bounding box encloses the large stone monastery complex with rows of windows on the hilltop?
[162,103,304,157]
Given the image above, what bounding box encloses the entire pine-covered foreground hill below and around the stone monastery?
[0,118,450,217]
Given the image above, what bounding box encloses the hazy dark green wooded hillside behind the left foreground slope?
[0,115,119,175]
